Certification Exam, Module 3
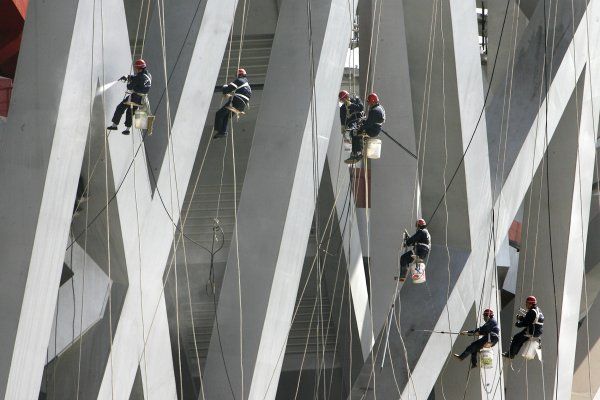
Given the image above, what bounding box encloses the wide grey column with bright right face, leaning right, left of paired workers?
[204,0,351,399]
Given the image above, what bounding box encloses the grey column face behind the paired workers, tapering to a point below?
[361,1,420,334]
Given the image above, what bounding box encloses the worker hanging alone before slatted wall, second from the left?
[213,68,252,139]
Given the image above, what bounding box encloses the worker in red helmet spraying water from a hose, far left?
[107,59,152,135]
